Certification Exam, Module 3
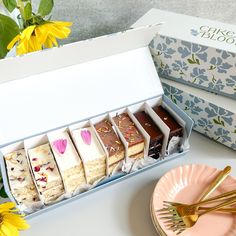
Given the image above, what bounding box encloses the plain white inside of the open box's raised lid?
[0,25,163,145]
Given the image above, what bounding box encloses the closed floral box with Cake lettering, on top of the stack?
[133,9,236,99]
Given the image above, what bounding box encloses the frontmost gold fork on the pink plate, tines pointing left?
[166,198,236,235]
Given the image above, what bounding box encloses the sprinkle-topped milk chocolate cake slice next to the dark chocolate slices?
[113,113,144,159]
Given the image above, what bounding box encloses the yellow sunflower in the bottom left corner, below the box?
[0,202,29,236]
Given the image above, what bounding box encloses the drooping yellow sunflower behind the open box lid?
[7,21,72,55]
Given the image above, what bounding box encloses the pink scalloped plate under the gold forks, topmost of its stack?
[151,165,236,236]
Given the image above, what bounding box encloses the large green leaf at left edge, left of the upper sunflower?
[0,14,20,59]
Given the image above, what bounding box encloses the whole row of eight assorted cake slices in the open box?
[5,106,182,208]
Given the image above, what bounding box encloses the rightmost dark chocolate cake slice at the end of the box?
[153,106,183,138]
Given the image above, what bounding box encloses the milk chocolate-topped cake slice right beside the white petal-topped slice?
[95,119,125,174]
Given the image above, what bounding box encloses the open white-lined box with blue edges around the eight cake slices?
[0,24,193,218]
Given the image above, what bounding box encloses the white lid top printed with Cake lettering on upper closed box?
[132,8,236,53]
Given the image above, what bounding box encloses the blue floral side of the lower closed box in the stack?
[163,83,236,150]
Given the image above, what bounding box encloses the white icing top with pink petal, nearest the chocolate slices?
[72,127,106,162]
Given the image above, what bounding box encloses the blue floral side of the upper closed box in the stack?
[150,35,236,99]
